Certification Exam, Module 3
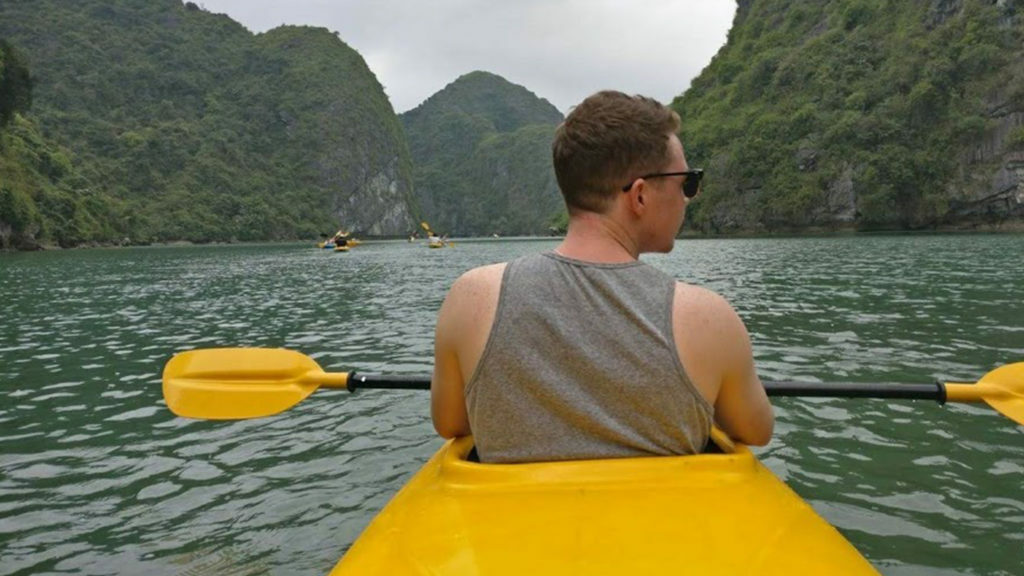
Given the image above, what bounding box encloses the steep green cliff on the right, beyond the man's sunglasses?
[673,0,1024,233]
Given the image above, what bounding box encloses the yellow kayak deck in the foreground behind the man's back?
[331,430,878,576]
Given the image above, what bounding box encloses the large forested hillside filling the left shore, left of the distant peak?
[0,0,414,244]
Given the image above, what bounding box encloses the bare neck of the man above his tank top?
[555,211,640,263]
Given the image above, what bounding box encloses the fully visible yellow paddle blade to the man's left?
[164,348,324,420]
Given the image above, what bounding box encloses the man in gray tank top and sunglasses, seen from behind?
[431,91,774,462]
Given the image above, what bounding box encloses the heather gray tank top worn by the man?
[466,252,713,462]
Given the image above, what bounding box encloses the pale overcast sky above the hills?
[196,0,736,113]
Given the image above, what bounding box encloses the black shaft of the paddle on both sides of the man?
[347,372,946,404]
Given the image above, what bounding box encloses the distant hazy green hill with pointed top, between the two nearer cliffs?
[400,72,564,236]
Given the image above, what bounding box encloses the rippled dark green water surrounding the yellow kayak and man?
[0,236,1024,575]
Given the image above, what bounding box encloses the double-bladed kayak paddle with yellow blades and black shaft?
[164,348,1024,424]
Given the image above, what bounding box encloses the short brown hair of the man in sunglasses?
[551,90,680,212]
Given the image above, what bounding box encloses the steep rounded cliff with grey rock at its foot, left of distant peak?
[258,27,416,236]
